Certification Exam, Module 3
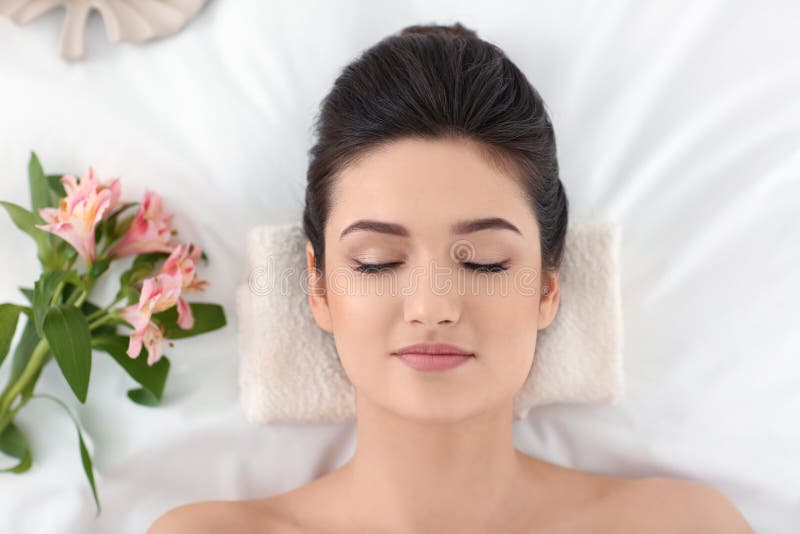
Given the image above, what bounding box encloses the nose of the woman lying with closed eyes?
[403,265,461,326]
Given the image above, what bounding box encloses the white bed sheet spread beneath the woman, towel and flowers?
[0,0,800,534]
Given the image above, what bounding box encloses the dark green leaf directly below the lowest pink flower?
[92,335,170,406]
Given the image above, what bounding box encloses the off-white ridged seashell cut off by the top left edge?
[0,0,206,59]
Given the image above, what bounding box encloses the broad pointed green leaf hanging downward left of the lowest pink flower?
[42,306,92,403]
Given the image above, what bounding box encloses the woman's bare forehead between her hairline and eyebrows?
[326,139,537,240]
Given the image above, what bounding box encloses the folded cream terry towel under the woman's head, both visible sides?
[236,222,624,424]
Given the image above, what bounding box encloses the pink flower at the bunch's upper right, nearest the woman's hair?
[108,190,175,257]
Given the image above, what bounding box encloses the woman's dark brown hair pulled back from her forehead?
[303,23,569,272]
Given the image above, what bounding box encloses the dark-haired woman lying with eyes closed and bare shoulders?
[150,24,752,534]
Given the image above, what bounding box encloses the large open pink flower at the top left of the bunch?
[35,167,120,263]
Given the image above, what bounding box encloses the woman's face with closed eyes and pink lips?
[306,139,559,421]
